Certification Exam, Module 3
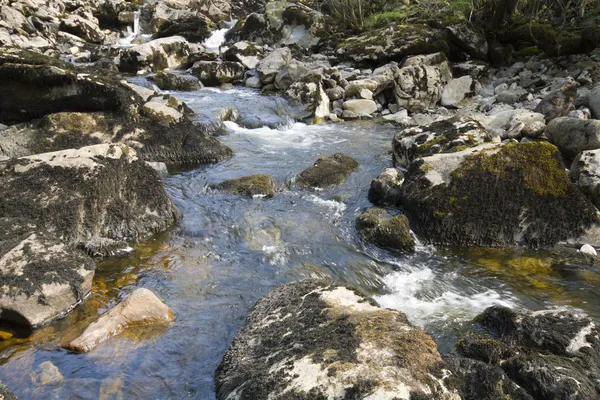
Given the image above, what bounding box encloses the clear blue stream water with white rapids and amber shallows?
[0,89,600,399]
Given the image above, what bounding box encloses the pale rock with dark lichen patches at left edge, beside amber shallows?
[0,231,95,328]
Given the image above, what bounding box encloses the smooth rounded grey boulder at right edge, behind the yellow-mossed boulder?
[546,117,600,158]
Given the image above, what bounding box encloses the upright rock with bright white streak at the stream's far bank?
[286,74,331,122]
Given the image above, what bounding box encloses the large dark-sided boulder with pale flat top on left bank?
[0,144,177,255]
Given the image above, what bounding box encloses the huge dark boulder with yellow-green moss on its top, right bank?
[402,142,597,247]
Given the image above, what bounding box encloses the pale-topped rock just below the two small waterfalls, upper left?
[119,36,191,73]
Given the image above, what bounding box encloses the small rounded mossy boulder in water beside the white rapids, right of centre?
[356,208,415,252]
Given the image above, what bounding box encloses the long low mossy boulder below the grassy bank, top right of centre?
[336,23,448,66]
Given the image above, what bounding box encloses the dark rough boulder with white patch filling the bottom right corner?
[450,306,600,400]
